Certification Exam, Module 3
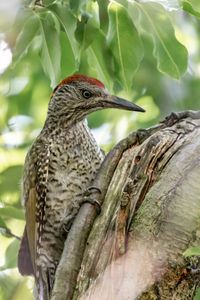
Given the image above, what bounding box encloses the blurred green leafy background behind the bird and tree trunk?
[0,0,200,300]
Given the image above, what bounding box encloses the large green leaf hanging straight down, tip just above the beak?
[107,2,143,91]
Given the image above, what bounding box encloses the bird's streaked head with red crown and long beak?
[48,74,145,125]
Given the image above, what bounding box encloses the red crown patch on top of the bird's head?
[53,74,105,94]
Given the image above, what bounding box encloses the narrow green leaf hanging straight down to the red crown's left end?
[40,13,61,88]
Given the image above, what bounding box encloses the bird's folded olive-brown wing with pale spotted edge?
[18,145,49,275]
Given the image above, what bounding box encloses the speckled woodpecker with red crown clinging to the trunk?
[18,74,144,300]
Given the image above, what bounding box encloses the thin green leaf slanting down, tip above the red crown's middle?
[48,3,79,64]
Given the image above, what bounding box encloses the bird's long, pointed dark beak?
[103,96,145,112]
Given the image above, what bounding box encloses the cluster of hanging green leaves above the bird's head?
[10,0,189,89]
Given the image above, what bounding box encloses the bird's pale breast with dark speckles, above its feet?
[47,134,103,199]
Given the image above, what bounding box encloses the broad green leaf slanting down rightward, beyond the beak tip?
[129,2,188,79]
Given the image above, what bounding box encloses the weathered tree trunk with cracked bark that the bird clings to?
[52,111,200,300]
